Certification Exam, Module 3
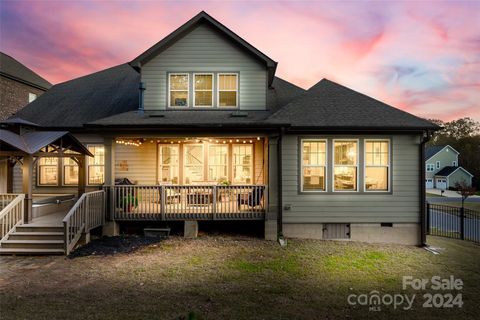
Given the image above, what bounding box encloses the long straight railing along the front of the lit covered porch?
[105,185,266,220]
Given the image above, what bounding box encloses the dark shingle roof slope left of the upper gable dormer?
[15,64,140,128]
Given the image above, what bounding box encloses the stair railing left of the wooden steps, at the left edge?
[0,194,25,245]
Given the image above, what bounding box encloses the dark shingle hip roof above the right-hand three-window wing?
[268,79,437,130]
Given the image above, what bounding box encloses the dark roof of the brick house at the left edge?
[0,52,52,90]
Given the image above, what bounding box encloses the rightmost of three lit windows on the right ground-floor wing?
[365,140,390,191]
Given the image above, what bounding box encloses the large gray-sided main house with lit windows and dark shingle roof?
[0,12,438,250]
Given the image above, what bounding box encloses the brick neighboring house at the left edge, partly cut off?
[0,52,52,120]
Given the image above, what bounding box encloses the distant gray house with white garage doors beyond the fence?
[425,145,473,190]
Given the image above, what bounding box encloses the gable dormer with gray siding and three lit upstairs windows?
[131,11,277,110]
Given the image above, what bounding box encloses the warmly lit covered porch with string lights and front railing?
[104,135,268,220]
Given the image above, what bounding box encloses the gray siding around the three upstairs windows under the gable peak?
[142,24,267,110]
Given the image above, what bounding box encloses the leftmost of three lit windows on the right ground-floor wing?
[302,140,327,191]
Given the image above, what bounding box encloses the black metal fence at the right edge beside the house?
[426,203,480,243]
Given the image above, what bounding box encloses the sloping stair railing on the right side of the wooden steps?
[63,190,105,255]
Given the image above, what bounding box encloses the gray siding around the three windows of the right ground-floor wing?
[282,135,423,223]
